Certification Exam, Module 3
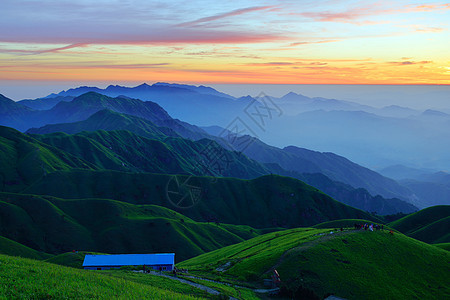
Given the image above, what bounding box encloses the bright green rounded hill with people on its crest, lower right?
[179,228,450,299]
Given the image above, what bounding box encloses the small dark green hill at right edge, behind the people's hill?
[389,205,450,244]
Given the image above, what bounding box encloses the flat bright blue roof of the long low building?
[83,253,175,267]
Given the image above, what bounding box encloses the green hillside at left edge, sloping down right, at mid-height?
[0,126,96,191]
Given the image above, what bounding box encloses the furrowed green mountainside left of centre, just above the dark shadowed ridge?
[33,130,269,178]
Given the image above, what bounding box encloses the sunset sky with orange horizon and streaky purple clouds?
[0,0,450,98]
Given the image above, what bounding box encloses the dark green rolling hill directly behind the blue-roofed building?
[0,193,259,260]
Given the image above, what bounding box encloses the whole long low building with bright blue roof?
[83,253,175,271]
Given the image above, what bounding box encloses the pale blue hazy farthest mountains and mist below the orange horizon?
[11,83,450,171]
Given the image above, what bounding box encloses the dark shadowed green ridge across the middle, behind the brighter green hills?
[24,170,376,228]
